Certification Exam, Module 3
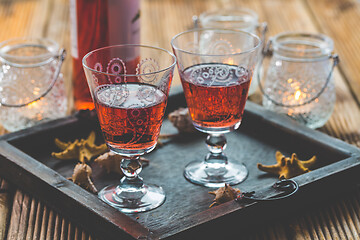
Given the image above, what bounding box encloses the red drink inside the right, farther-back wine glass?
[180,63,251,130]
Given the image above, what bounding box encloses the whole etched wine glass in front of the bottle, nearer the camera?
[83,44,176,213]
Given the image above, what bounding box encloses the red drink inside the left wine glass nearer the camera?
[95,83,166,150]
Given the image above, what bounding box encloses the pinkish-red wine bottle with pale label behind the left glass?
[70,0,140,110]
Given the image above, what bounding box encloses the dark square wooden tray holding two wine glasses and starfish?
[0,90,360,239]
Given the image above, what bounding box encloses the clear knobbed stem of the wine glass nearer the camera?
[115,156,146,200]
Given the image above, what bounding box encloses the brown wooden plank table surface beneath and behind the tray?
[0,0,360,240]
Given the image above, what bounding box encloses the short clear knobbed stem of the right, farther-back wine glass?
[205,134,228,166]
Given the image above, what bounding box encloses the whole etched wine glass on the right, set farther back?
[171,28,261,187]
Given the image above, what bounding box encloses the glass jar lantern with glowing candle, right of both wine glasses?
[262,33,338,128]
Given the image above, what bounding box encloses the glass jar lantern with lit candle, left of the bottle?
[0,38,67,132]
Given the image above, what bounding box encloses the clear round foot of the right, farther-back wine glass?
[184,161,249,188]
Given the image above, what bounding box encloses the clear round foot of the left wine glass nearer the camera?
[98,184,165,213]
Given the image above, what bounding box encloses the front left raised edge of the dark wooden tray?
[0,141,151,239]
